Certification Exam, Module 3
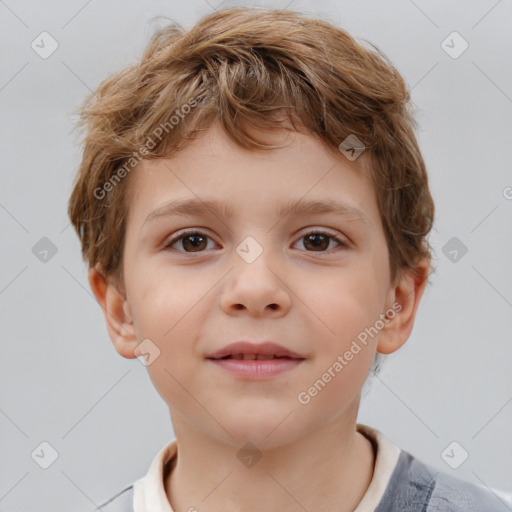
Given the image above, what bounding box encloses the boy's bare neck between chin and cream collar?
[165,418,374,512]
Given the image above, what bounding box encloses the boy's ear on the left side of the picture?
[89,267,139,359]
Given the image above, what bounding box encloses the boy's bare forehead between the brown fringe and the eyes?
[128,125,378,227]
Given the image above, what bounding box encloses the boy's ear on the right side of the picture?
[377,258,430,354]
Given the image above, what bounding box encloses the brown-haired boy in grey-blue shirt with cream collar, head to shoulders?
[69,8,503,512]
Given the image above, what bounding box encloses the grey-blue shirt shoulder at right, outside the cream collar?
[376,450,504,512]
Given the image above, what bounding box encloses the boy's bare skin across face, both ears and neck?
[89,125,428,512]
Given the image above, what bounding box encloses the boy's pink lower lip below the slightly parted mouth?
[208,359,304,380]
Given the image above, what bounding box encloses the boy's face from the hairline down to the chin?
[109,126,408,447]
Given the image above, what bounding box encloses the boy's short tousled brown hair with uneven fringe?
[68,7,434,289]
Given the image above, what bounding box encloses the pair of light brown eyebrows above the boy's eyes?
[143,198,371,227]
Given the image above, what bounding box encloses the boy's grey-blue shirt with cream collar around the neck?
[99,423,510,512]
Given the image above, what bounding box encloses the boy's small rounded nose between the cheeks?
[221,246,291,317]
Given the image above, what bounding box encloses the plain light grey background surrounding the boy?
[0,0,512,512]
